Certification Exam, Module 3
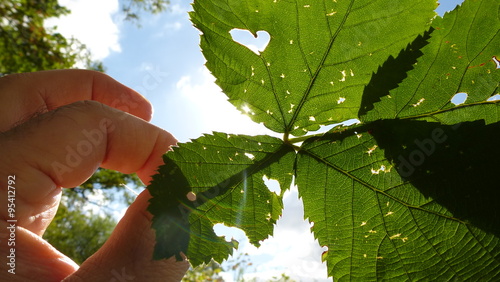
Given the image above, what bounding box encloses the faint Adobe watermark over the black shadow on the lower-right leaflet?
[397,123,461,177]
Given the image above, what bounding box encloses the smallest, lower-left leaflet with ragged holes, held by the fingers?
[148,133,295,265]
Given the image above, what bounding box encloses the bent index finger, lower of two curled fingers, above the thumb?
[0,101,176,235]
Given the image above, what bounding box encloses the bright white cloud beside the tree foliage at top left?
[46,0,121,60]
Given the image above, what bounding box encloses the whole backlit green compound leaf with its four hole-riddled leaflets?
[148,0,500,280]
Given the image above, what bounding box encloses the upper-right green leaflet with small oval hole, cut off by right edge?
[361,0,500,124]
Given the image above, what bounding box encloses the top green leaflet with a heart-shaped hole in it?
[191,0,436,136]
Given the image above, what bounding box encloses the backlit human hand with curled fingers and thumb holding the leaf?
[0,70,189,281]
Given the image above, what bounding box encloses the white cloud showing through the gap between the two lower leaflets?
[215,187,331,281]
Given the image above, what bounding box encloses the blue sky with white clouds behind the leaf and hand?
[47,0,462,281]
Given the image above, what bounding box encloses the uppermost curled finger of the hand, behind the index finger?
[0,70,153,132]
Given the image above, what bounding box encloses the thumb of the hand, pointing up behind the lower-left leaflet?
[65,190,189,281]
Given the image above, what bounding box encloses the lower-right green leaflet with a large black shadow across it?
[297,120,500,281]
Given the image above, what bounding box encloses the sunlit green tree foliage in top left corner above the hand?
[0,0,92,75]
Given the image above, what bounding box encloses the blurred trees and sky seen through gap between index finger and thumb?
[43,168,142,263]
